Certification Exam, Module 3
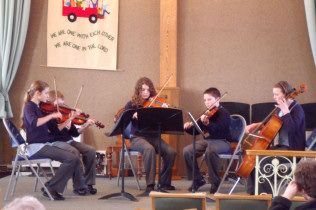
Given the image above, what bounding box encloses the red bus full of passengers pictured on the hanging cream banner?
[62,0,109,23]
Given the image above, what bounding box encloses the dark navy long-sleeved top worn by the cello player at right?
[281,101,306,150]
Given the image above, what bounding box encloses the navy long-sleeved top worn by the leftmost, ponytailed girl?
[23,101,54,144]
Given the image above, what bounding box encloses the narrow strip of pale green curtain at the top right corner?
[304,0,316,66]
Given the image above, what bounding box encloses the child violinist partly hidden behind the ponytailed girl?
[49,90,97,195]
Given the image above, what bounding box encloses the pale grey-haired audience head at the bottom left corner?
[3,196,46,210]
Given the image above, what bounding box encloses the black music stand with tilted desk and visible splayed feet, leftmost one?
[99,110,138,201]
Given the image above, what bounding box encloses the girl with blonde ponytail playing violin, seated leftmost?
[22,81,80,200]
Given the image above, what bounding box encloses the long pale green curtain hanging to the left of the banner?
[0,0,31,118]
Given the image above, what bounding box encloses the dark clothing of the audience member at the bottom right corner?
[269,196,316,210]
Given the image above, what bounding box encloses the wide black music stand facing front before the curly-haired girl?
[137,108,183,191]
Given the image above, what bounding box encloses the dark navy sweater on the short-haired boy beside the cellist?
[186,106,231,141]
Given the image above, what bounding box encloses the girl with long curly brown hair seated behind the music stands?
[125,77,176,195]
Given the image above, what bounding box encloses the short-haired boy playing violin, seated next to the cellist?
[183,87,230,193]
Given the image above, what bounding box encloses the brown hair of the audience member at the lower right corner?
[294,160,316,198]
